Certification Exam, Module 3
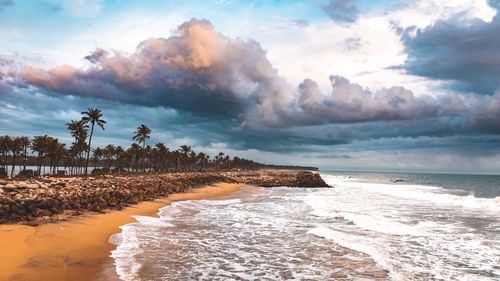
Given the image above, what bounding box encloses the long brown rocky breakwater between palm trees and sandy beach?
[0,168,328,224]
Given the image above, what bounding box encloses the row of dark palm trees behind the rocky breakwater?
[0,108,274,177]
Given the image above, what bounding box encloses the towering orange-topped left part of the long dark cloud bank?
[21,19,293,123]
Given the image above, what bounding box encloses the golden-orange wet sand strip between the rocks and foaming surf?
[0,183,246,281]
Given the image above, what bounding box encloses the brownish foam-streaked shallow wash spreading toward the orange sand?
[112,185,382,281]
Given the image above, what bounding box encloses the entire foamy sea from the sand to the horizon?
[110,172,500,281]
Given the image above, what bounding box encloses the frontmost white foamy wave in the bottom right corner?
[308,221,500,281]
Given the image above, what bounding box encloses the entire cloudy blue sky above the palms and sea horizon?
[0,0,500,174]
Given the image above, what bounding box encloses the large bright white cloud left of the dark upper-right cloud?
[243,0,495,94]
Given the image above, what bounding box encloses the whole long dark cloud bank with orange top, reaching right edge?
[10,19,500,147]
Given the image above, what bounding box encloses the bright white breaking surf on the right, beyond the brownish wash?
[310,175,500,280]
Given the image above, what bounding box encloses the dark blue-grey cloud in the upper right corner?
[398,0,500,95]
